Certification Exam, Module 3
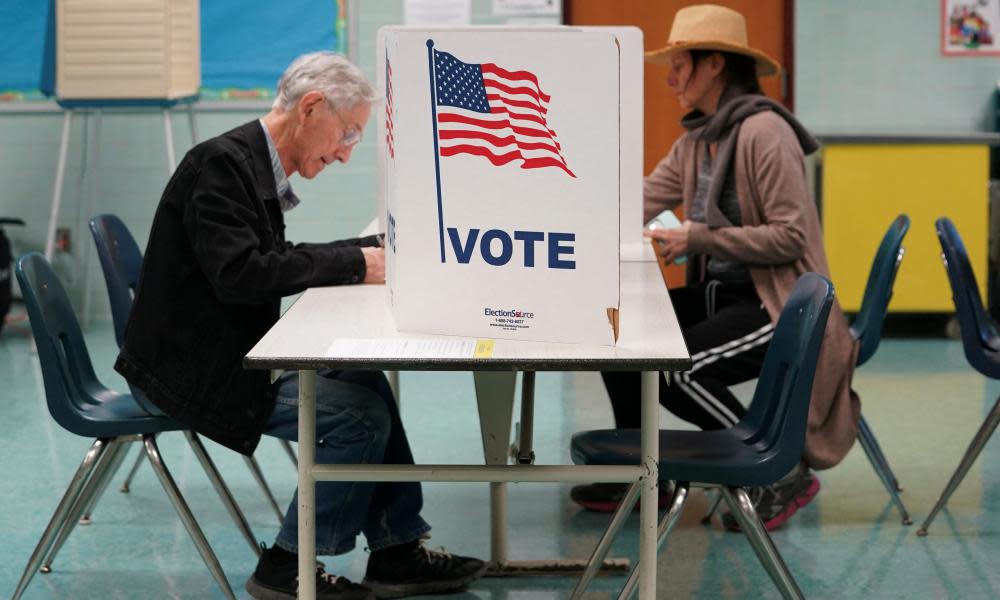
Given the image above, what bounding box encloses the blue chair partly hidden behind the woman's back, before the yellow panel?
[851,215,913,525]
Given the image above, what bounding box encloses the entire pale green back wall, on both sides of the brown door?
[0,0,1000,319]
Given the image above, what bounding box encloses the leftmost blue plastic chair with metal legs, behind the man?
[12,253,249,600]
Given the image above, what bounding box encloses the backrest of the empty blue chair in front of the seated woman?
[739,273,833,477]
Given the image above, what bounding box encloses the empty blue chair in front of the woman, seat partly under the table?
[570,273,833,598]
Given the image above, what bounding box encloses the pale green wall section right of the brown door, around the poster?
[795,0,1000,133]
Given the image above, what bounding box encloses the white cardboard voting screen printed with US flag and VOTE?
[377,27,621,345]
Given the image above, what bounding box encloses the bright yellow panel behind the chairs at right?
[822,143,989,312]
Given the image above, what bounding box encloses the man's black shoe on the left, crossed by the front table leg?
[246,544,375,600]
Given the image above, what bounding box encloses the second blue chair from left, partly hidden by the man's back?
[84,214,295,524]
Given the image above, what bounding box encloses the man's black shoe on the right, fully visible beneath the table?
[363,540,486,598]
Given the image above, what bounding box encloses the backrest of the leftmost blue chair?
[15,252,107,435]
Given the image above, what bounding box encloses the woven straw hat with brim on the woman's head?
[646,4,781,77]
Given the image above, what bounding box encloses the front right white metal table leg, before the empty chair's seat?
[639,371,660,600]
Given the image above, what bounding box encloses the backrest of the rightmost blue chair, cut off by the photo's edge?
[934,217,1000,377]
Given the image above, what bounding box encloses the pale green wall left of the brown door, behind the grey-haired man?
[0,0,561,321]
